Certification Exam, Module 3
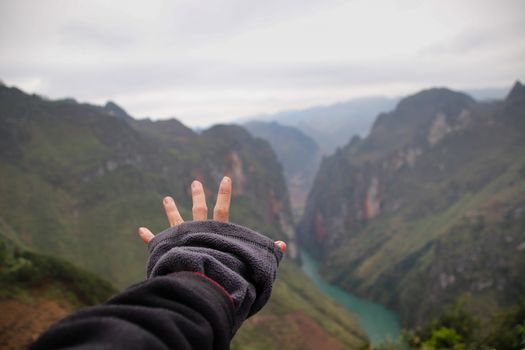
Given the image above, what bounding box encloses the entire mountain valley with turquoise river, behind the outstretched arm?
[0,82,525,349]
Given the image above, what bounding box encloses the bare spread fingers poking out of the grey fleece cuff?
[139,176,286,253]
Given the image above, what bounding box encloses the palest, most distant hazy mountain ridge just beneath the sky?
[242,97,397,154]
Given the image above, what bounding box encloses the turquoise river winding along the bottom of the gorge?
[301,249,401,345]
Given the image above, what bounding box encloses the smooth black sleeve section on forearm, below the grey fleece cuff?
[30,272,234,349]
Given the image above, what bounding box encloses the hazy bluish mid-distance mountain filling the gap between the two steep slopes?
[243,121,321,217]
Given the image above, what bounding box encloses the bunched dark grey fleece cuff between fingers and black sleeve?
[147,220,283,333]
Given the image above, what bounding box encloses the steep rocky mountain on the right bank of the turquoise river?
[299,83,525,326]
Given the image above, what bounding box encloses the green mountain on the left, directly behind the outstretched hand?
[0,86,368,349]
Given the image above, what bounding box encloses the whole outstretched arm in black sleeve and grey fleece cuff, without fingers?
[30,221,282,349]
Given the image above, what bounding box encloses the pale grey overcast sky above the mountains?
[0,0,525,126]
